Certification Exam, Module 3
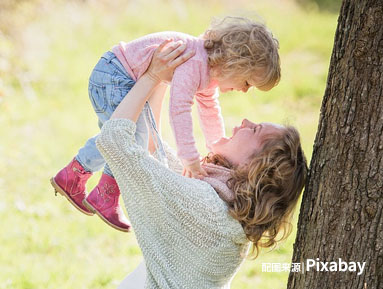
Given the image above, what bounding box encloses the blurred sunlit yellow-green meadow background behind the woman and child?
[0,0,340,289]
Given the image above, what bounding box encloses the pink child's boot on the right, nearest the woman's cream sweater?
[83,174,131,232]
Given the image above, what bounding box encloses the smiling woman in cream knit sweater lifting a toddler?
[97,41,306,289]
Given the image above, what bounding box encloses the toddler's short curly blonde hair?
[203,16,281,91]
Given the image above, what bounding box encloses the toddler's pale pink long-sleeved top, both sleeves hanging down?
[112,31,225,164]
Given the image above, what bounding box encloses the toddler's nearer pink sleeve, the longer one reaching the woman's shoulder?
[169,60,200,164]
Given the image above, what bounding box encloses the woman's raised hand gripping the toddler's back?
[145,39,195,82]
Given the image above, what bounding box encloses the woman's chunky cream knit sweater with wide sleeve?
[96,119,249,289]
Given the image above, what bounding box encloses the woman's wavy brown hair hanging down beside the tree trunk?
[205,126,307,259]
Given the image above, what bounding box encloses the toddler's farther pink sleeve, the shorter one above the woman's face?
[196,89,225,151]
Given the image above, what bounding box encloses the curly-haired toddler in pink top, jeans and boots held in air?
[51,17,280,232]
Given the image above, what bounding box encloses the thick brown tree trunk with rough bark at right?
[287,0,383,289]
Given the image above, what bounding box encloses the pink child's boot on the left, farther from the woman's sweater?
[51,158,94,216]
